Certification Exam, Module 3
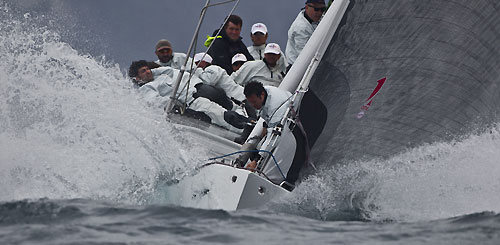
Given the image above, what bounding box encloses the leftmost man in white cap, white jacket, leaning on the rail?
[194,53,245,101]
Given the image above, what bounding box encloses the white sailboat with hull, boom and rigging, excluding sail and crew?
[166,0,349,211]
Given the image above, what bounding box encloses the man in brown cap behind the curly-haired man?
[155,39,192,70]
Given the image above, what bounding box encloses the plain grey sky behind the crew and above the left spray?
[7,0,305,69]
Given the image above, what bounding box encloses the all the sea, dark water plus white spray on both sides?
[0,2,500,244]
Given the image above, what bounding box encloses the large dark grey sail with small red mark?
[311,0,500,164]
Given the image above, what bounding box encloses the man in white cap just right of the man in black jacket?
[247,23,288,70]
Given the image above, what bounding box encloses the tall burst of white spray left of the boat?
[0,6,205,204]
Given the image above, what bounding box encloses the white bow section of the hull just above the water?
[168,164,290,211]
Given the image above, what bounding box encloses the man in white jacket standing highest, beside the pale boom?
[285,0,326,65]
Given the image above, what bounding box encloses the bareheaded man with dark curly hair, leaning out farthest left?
[129,60,241,133]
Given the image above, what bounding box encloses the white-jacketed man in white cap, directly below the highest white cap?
[231,43,285,87]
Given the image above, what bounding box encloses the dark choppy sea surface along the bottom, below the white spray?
[0,199,500,244]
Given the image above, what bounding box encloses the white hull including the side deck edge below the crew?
[165,122,290,211]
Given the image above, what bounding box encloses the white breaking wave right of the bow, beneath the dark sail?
[278,125,500,221]
